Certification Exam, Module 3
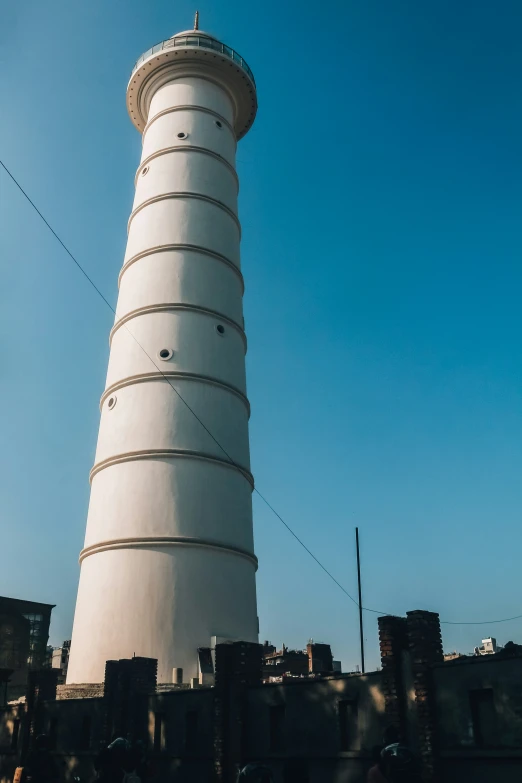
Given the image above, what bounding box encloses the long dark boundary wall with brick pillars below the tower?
[4,611,522,783]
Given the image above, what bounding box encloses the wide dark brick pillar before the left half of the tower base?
[103,658,158,742]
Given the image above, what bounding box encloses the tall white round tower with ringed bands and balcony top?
[67,17,258,683]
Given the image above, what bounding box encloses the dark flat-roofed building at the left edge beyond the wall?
[0,596,54,699]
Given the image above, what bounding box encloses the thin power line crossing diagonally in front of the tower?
[0,155,522,625]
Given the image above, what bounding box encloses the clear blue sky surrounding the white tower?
[0,0,522,669]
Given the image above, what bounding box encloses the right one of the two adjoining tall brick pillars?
[406,610,444,783]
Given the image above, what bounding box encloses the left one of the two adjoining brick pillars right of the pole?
[377,615,408,741]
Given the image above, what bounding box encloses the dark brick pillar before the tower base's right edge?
[214,642,263,783]
